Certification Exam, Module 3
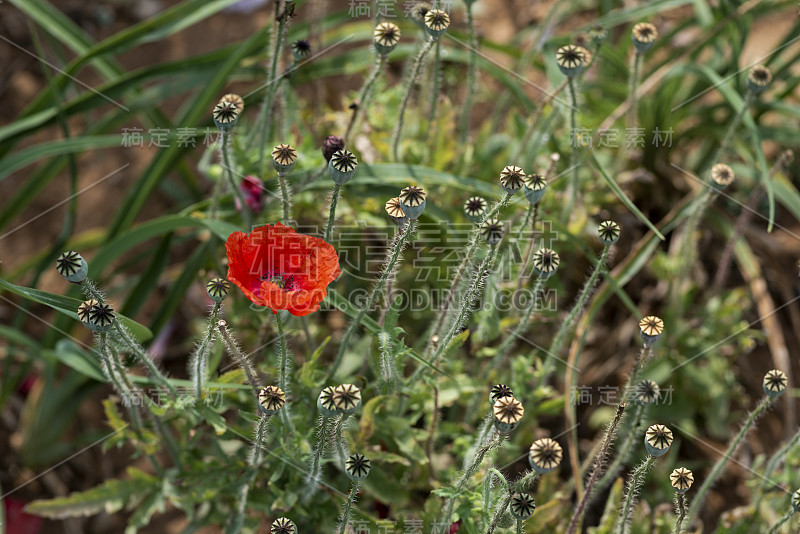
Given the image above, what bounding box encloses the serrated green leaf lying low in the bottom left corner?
[25,467,160,519]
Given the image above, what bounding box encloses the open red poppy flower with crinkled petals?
[225,223,342,316]
